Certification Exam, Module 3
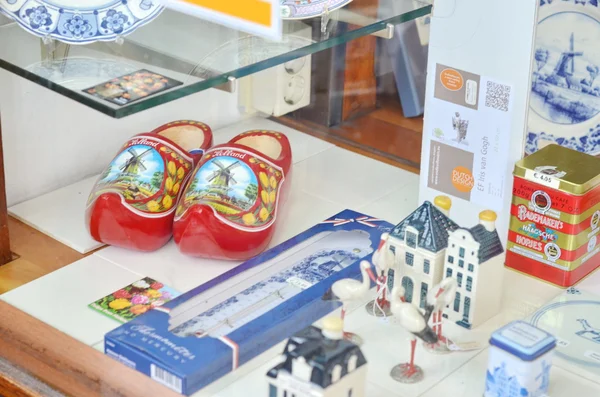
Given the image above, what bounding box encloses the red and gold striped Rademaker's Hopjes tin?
[506,145,600,287]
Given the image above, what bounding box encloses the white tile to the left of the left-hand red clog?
[8,176,104,254]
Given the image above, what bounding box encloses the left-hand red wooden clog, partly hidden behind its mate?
[85,121,213,251]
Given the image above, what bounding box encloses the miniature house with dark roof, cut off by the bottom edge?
[267,317,367,397]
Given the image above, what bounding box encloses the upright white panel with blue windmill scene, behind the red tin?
[525,0,600,154]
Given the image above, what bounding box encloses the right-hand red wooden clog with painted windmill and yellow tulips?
[173,130,292,260]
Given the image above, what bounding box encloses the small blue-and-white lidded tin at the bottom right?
[484,321,556,397]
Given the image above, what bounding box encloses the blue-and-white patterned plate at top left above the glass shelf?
[0,0,163,44]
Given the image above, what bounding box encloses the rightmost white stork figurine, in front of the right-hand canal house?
[425,277,458,353]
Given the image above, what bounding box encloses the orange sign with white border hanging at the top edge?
[161,0,282,40]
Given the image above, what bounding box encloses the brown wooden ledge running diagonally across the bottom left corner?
[0,302,180,397]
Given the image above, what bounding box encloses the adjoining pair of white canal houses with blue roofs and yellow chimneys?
[377,196,504,329]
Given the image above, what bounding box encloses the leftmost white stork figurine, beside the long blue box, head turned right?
[324,261,376,344]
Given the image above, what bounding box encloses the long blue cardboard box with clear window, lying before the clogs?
[104,210,393,395]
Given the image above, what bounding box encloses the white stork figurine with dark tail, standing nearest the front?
[390,287,438,383]
